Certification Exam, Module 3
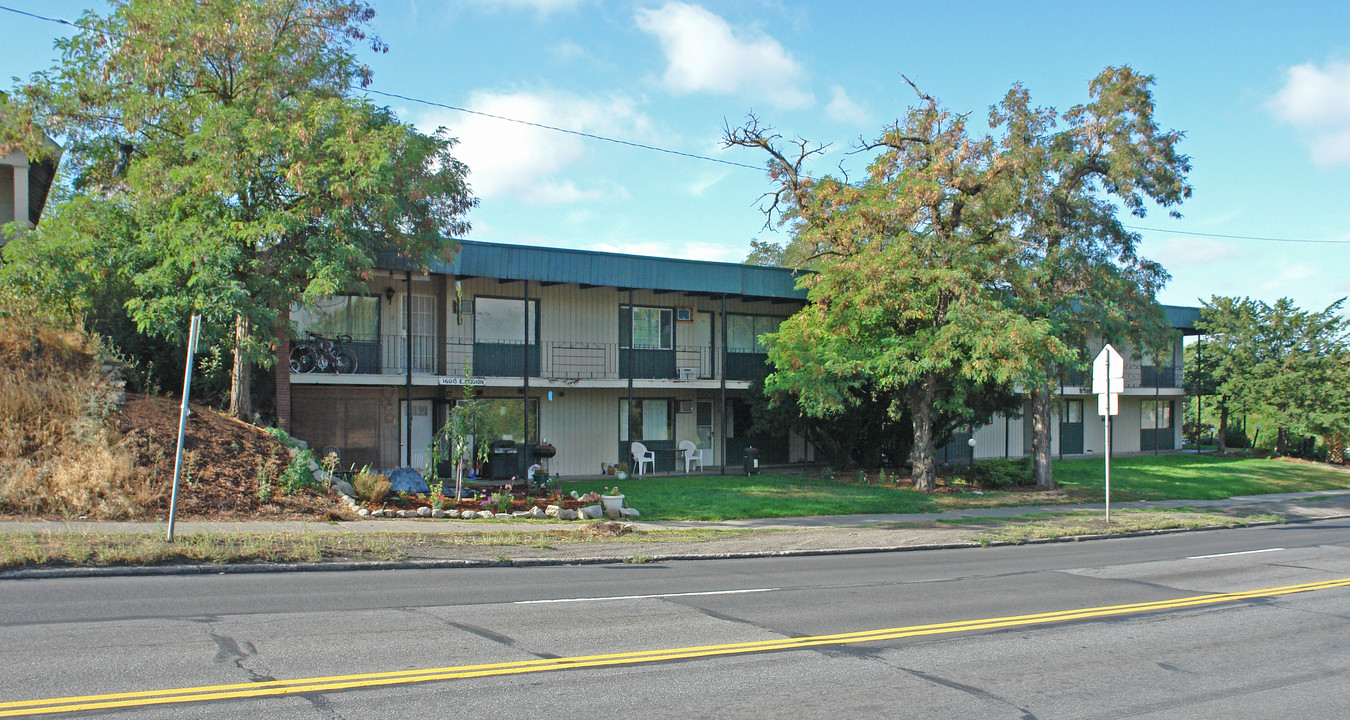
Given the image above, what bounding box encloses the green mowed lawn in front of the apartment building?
[563,455,1350,520]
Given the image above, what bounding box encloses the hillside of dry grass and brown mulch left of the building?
[0,297,340,520]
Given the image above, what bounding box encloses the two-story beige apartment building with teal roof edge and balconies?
[277,240,1193,475]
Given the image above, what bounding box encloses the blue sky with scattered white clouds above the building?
[0,0,1350,309]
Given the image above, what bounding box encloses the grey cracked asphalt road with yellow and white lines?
[0,520,1350,720]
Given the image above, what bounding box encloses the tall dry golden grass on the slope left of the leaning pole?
[0,296,153,520]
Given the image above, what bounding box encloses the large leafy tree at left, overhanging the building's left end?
[7,0,477,417]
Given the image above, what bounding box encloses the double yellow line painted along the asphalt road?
[0,578,1350,717]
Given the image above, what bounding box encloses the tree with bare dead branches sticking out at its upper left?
[725,85,1067,490]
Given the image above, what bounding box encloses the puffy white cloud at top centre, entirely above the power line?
[637,3,813,108]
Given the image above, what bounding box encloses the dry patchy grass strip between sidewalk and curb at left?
[0,530,751,571]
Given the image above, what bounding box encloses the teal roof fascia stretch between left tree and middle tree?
[375,240,806,303]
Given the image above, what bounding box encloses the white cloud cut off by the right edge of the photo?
[1270,62,1350,166]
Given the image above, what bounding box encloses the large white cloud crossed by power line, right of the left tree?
[416,92,651,204]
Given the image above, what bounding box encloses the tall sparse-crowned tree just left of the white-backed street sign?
[990,66,1191,488]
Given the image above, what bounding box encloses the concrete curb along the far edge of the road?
[0,513,1350,580]
